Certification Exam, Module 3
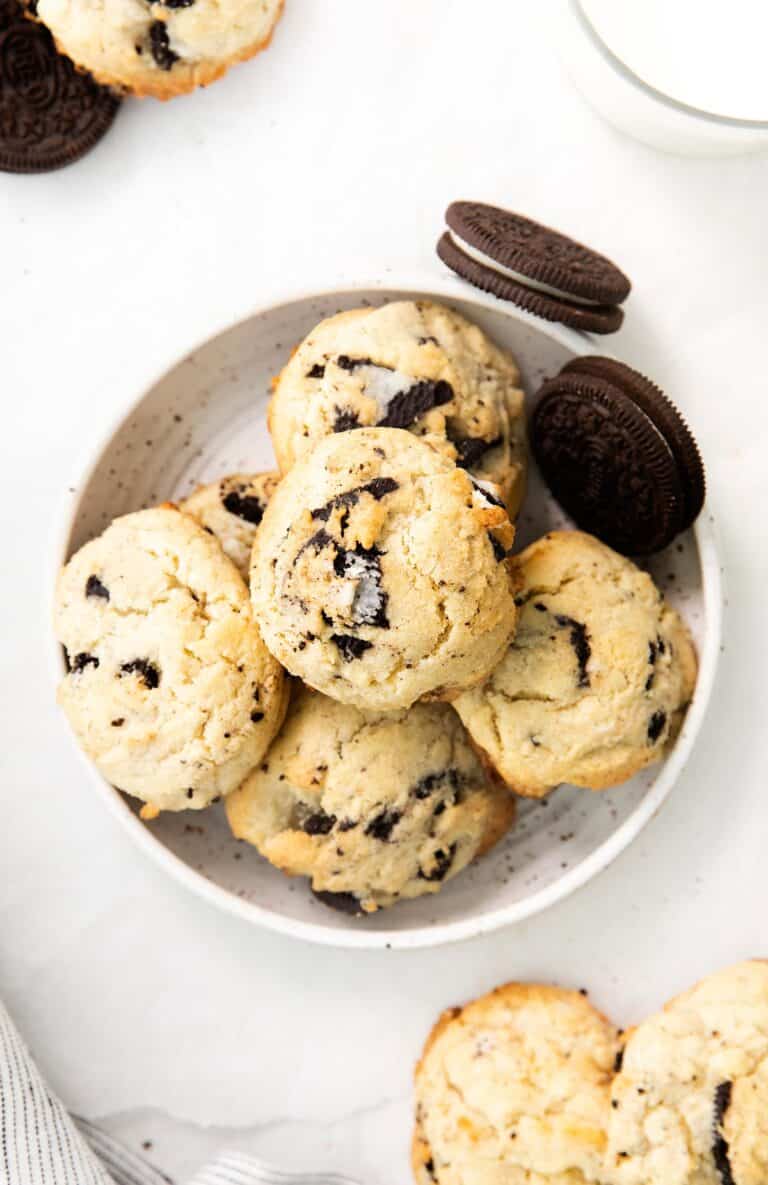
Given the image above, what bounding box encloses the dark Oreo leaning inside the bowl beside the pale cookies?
[531,357,705,556]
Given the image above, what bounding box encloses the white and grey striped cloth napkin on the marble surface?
[0,1004,352,1185]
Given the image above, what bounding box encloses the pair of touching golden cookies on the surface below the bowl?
[412,961,768,1185]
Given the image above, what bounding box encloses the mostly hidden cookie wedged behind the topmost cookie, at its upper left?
[179,473,280,581]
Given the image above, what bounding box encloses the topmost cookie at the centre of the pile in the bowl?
[250,428,516,711]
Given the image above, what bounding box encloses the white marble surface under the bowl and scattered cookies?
[0,0,768,1185]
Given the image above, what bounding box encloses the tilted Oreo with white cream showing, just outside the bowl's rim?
[437,201,632,333]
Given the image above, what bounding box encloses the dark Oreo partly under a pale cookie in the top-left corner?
[0,0,120,173]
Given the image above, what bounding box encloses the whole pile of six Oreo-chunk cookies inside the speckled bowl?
[57,301,696,912]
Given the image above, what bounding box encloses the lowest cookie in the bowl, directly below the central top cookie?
[226,684,514,912]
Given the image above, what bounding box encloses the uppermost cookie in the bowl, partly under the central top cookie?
[269,301,526,515]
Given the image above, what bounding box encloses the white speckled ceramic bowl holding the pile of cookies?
[50,276,722,947]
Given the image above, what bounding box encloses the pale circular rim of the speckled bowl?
[46,274,724,950]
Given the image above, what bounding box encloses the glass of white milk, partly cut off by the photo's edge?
[556,0,768,156]
